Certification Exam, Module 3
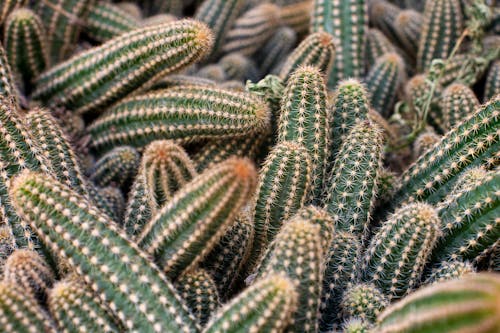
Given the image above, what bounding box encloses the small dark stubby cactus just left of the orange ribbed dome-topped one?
[89,146,141,187]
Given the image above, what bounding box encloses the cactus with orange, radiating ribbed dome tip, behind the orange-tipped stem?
[125,140,197,237]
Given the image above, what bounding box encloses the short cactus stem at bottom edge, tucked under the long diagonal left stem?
[48,276,121,333]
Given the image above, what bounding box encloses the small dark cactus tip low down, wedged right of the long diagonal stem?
[175,269,219,326]
